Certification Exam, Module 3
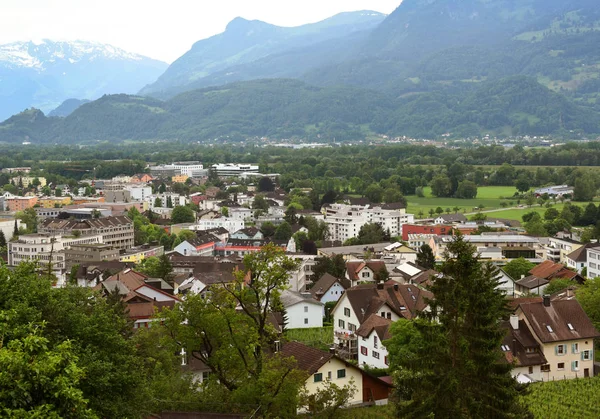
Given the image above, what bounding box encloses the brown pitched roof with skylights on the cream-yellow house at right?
[519,300,600,343]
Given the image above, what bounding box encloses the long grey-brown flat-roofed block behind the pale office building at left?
[38,216,134,250]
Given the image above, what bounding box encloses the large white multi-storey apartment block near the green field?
[325,204,414,242]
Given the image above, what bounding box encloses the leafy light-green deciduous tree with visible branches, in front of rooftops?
[163,245,306,417]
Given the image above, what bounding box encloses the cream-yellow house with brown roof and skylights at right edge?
[515,296,600,381]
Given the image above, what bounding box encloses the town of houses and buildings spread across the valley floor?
[0,161,600,416]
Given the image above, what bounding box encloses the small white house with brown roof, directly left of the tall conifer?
[356,314,392,368]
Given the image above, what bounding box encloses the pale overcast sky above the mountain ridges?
[0,0,401,62]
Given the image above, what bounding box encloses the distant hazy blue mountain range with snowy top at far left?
[0,40,168,120]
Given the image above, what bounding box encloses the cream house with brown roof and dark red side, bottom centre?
[281,342,392,405]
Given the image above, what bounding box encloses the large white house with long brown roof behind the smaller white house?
[331,281,433,359]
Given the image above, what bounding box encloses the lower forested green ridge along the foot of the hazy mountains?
[0,76,600,143]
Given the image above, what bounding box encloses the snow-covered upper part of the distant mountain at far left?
[0,39,152,71]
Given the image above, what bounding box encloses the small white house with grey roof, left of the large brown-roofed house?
[280,290,324,329]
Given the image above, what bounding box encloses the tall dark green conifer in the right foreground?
[386,236,527,418]
